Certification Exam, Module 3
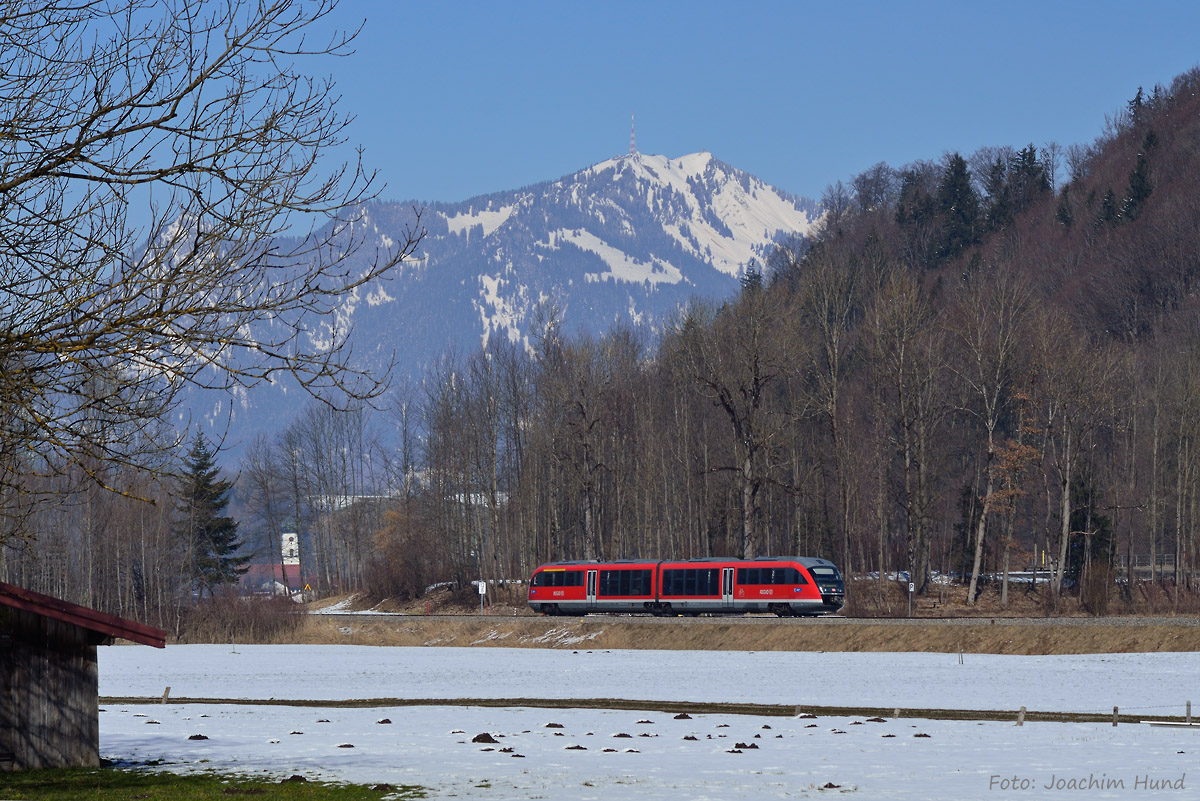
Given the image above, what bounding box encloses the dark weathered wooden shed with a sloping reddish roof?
[0,582,167,771]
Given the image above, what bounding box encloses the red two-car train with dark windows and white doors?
[529,556,846,618]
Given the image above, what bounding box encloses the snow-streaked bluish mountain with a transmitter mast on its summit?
[193,152,818,446]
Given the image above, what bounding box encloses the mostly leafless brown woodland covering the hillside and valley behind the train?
[9,71,1200,620]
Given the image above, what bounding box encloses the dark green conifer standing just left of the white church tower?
[176,434,250,597]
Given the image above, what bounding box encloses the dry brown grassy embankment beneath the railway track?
[295,615,1200,655]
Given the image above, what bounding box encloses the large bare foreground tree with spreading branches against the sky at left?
[0,0,420,537]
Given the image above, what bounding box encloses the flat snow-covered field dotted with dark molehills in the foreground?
[100,645,1200,801]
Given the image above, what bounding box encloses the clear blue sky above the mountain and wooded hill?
[324,0,1200,201]
